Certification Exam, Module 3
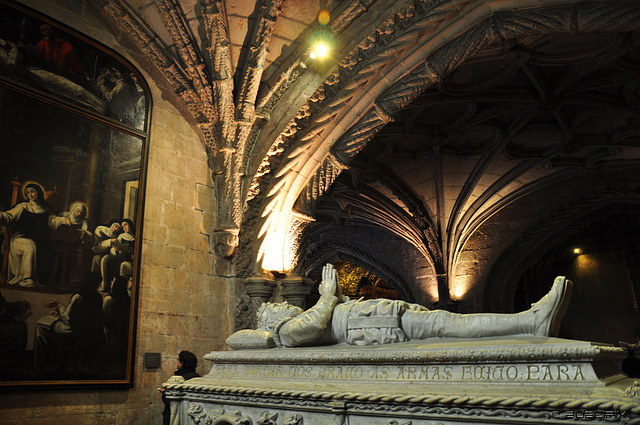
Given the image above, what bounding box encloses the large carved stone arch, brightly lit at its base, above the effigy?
[242,0,640,288]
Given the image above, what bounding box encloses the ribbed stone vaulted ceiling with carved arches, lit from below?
[90,0,640,308]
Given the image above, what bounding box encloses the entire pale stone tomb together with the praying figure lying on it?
[165,264,640,425]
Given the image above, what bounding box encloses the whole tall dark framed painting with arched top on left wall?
[0,0,149,390]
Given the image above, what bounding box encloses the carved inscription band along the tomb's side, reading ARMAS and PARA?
[211,363,595,383]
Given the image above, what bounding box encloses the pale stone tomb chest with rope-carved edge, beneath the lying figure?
[164,337,640,425]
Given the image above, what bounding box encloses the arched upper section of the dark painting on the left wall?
[0,4,146,130]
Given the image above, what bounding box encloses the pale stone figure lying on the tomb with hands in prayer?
[227,264,572,349]
